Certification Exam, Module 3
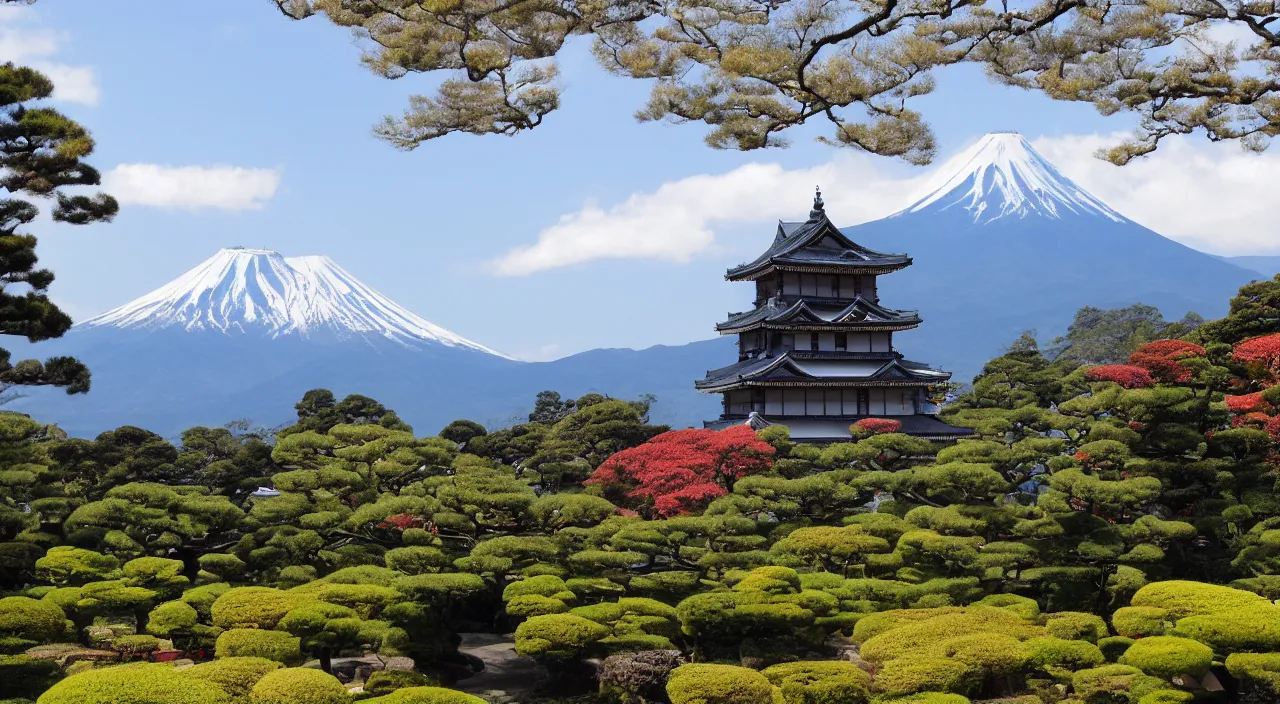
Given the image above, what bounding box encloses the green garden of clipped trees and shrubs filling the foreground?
[0,279,1280,704]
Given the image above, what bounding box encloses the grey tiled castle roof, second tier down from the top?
[716,296,922,334]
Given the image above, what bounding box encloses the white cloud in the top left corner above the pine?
[0,5,101,105]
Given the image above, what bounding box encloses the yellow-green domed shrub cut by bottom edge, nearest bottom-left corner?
[40,663,230,704]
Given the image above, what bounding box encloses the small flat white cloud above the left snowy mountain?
[102,164,280,210]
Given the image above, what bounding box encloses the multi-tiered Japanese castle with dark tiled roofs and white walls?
[695,192,970,442]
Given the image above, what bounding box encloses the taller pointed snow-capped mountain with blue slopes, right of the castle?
[844,133,1258,380]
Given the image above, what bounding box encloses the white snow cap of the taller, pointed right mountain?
[896,132,1128,224]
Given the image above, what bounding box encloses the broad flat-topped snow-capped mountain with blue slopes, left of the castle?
[0,248,733,438]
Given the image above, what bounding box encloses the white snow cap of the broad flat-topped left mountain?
[77,248,506,357]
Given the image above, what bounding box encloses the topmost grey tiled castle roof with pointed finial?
[724,192,911,280]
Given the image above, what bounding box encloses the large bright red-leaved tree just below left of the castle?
[584,425,774,517]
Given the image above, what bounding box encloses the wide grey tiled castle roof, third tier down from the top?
[694,352,951,393]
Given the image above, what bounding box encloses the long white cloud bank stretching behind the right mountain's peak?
[490,134,1280,276]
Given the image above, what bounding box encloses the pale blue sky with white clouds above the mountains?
[12,0,1280,358]
